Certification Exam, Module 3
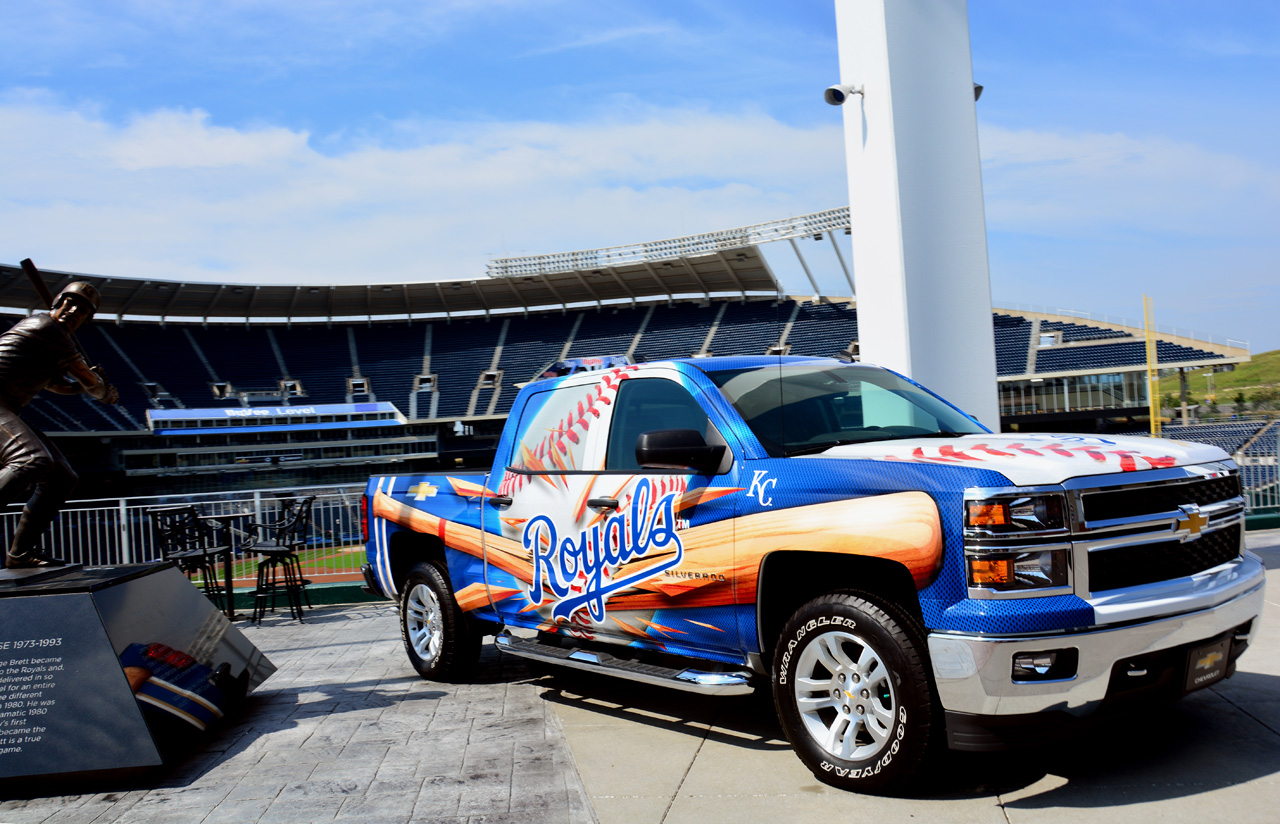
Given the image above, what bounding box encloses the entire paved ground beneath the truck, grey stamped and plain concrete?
[0,531,1280,824]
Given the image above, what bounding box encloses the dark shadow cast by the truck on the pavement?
[524,670,1280,810]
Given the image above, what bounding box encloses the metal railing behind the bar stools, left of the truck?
[0,484,365,583]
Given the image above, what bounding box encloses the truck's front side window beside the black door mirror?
[604,377,710,471]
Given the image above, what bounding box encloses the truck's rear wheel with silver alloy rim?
[399,562,480,681]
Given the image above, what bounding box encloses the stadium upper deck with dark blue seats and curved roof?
[0,209,1249,450]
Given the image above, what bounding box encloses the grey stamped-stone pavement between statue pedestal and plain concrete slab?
[0,603,594,824]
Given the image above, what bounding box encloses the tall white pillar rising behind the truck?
[823,0,1000,430]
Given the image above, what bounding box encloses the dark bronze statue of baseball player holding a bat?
[0,280,120,569]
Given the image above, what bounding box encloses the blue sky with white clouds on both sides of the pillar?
[0,0,1280,352]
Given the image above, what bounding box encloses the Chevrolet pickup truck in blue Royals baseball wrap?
[365,356,1265,791]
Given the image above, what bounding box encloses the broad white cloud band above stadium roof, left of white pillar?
[0,96,846,281]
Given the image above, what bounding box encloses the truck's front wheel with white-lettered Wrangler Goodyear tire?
[773,592,933,792]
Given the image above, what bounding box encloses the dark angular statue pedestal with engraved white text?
[0,562,275,796]
